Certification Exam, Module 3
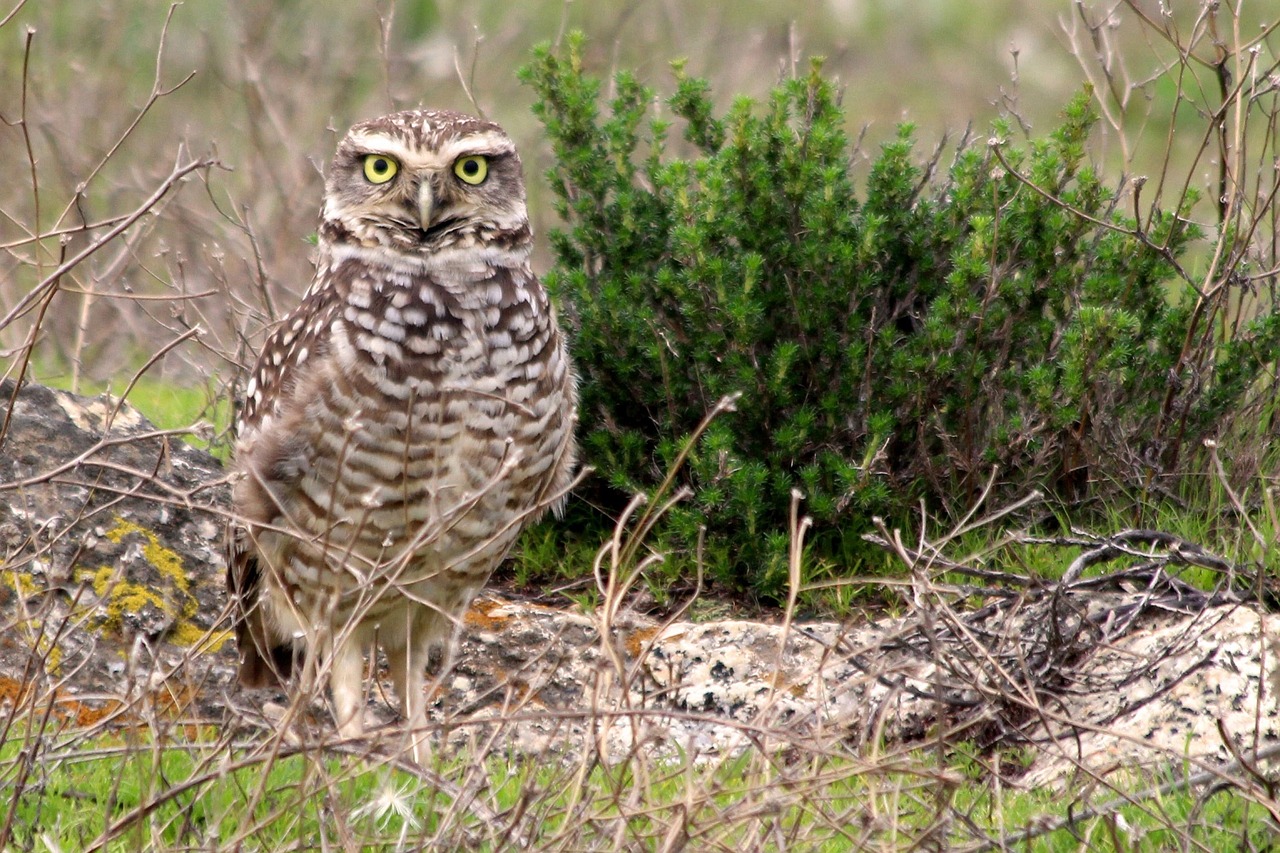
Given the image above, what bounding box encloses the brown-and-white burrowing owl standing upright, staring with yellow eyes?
[228,110,576,753]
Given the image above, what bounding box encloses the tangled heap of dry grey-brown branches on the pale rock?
[852,517,1248,747]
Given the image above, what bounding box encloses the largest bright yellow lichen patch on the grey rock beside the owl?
[76,517,212,651]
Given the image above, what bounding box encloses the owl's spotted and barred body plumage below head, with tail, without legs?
[228,248,576,684]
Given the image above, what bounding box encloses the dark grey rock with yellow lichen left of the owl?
[0,380,228,713]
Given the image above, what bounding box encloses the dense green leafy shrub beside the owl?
[522,34,1277,598]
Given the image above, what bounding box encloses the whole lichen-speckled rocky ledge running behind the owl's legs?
[0,382,1280,785]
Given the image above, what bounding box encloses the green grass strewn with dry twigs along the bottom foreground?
[0,733,1276,850]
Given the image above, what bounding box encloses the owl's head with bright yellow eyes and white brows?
[321,110,531,254]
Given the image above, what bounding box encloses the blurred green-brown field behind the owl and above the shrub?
[0,0,1263,409]
